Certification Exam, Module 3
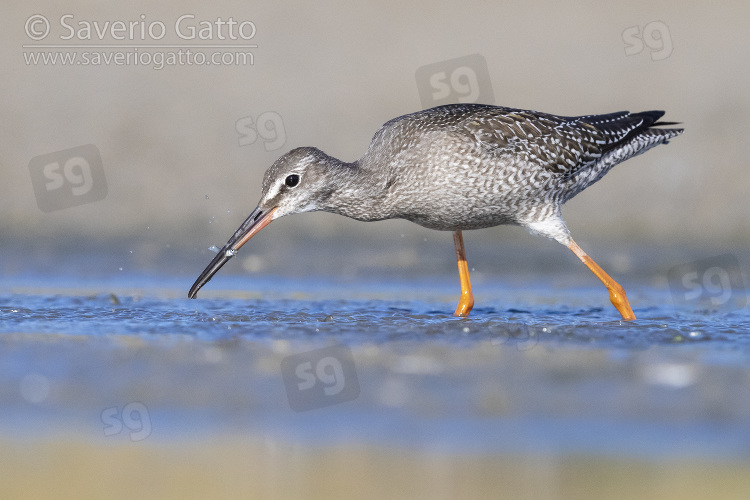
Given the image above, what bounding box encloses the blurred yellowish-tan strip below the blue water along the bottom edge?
[0,435,750,500]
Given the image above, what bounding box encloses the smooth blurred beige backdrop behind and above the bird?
[0,0,750,274]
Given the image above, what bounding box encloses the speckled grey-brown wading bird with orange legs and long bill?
[188,104,683,320]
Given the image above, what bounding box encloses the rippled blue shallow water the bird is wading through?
[0,275,750,460]
